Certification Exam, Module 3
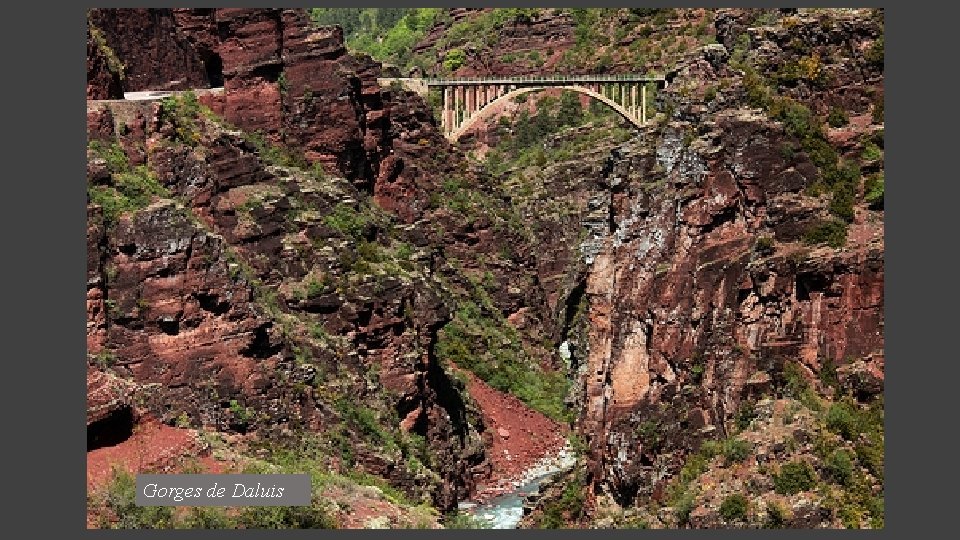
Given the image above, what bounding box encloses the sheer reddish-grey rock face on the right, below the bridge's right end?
[581,123,883,506]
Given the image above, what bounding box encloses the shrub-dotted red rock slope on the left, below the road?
[87,78,484,508]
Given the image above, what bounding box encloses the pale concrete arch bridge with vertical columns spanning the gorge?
[379,75,667,141]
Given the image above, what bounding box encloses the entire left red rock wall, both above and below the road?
[88,9,492,508]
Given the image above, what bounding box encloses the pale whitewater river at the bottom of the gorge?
[460,444,576,529]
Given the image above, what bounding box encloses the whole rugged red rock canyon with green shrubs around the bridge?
[86,8,884,528]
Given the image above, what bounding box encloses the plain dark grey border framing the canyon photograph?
[3,0,928,538]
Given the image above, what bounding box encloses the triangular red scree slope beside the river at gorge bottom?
[459,370,568,502]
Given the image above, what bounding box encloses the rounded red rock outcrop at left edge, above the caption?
[88,196,316,429]
